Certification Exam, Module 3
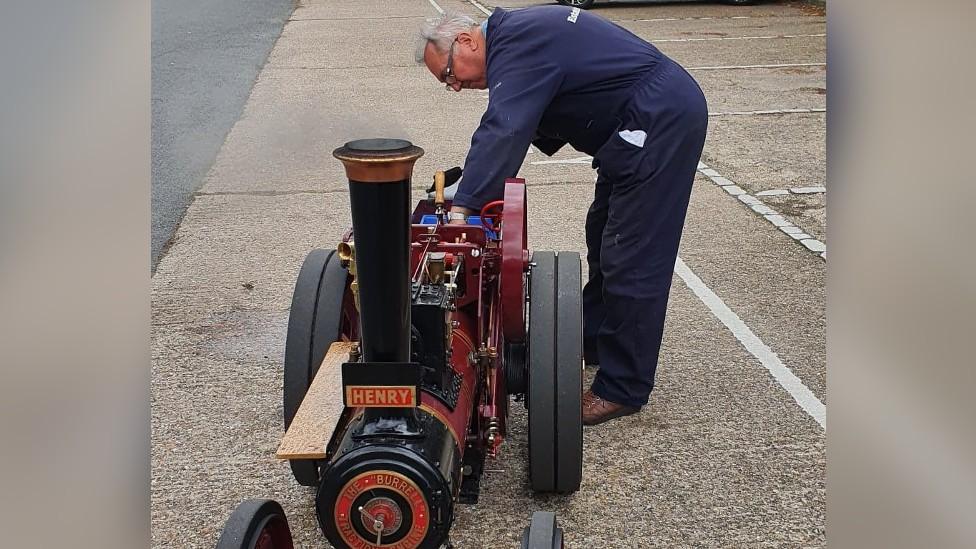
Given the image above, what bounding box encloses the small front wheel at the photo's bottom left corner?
[217,499,295,549]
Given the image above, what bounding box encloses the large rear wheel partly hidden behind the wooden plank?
[284,250,358,486]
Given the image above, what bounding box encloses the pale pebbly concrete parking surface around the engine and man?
[151,0,827,549]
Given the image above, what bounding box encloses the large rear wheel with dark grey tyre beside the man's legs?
[526,252,583,494]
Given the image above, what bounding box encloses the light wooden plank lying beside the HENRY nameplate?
[275,341,355,459]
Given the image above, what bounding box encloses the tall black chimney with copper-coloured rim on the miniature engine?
[332,139,424,362]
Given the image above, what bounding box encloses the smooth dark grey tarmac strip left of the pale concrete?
[151,0,293,269]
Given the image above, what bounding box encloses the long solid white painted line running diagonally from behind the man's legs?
[674,257,827,431]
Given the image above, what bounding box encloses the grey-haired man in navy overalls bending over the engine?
[417,6,708,425]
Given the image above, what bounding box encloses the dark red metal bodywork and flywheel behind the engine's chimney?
[410,178,528,456]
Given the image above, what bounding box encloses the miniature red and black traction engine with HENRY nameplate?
[218,139,583,549]
